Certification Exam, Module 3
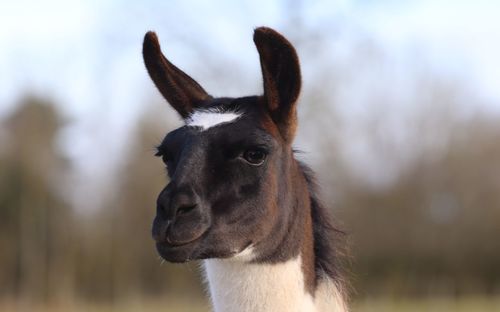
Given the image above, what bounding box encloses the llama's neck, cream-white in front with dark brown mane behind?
[204,162,348,312]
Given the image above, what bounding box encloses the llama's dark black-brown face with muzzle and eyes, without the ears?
[153,97,286,261]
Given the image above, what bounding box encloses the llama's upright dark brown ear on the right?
[253,27,301,142]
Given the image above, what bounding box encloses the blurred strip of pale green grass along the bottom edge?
[0,297,500,312]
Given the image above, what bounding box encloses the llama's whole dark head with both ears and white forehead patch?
[143,27,301,262]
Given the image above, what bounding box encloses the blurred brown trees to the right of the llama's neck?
[338,117,500,295]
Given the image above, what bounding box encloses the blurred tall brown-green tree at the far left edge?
[0,97,72,301]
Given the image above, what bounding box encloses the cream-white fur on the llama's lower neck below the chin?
[204,257,346,312]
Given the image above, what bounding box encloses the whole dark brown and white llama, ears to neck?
[143,27,347,312]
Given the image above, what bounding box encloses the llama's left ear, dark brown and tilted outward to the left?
[142,31,211,118]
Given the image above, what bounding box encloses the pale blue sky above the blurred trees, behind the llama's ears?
[0,0,500,210]
